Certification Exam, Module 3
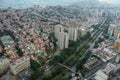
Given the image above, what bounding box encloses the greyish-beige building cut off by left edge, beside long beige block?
[0,58,10,73]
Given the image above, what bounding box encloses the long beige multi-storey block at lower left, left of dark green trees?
[10,57,30,75]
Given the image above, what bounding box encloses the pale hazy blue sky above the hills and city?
[0,0,120,8]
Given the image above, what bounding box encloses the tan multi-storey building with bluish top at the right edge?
[108,24,120,39]
